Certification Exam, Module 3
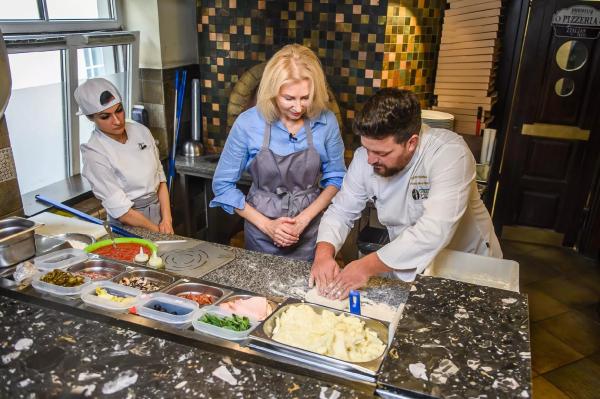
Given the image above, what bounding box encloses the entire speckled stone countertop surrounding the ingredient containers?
[0,229,531,398]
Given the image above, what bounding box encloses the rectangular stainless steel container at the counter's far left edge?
[0,216,39,267]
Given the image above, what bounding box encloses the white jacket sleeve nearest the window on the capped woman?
[82,148,133,219]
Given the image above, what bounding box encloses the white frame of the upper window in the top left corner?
[0,0,123,34]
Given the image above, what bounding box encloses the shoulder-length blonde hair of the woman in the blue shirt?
[256,44,329,123]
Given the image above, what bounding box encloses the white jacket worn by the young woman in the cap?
[81,121,167,219]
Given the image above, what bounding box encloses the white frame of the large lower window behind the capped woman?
[5,31,140,176]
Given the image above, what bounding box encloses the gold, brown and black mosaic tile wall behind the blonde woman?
[197,0,445,156]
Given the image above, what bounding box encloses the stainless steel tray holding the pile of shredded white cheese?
[249,298,389,380]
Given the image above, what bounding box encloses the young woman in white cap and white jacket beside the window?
[75,78,173,234]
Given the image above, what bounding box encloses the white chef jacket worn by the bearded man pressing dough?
[317,127,502,281]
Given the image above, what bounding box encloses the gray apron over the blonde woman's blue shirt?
[244,120,321,262]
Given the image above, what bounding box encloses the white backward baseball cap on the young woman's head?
[75,78,122,115]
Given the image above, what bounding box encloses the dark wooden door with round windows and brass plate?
[494,0,600,246]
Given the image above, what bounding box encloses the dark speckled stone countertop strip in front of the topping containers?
[0,295,371,398]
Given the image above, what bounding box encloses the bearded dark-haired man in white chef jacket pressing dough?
[309,89,502,298]
